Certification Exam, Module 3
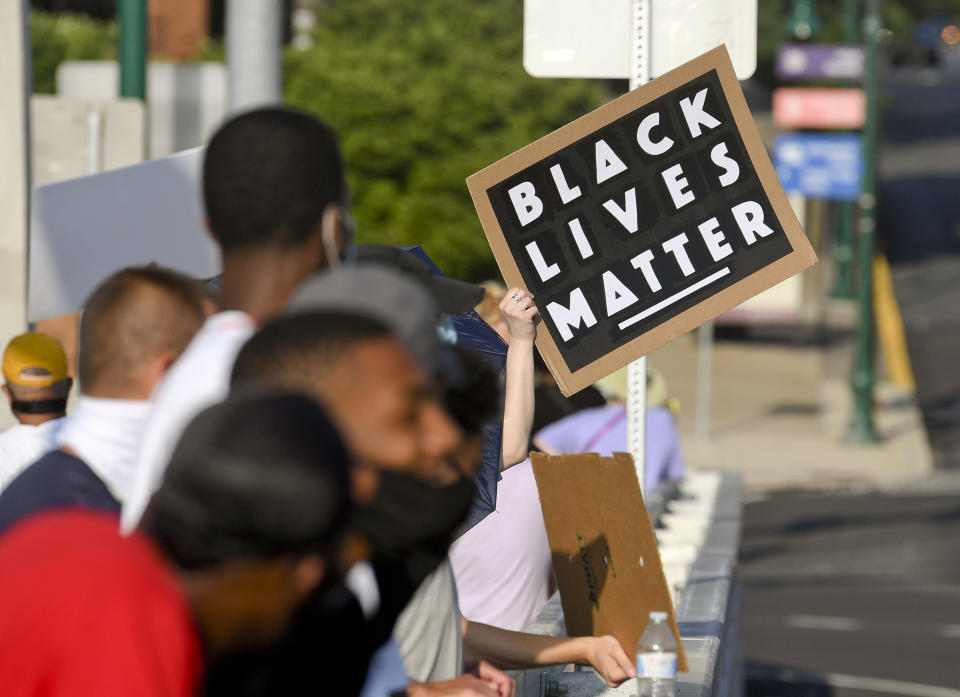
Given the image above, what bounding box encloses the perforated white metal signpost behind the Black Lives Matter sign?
[627,0,650,500]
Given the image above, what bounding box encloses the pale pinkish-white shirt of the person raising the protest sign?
[450,458,552,631]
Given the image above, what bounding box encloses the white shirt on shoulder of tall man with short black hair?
[120,310,256,533]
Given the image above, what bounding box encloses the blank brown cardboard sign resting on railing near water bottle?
[530,453,688,672]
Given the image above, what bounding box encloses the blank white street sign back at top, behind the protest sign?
[523,0,757,80]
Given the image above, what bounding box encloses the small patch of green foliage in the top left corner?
[30,10,117,94]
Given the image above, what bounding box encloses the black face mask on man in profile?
[354,470,474,587]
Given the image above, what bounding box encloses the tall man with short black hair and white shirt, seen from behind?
[121,107,352,532]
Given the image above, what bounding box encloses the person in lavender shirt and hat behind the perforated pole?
[533,367,684,494]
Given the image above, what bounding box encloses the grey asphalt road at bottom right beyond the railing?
[740,486,960,697]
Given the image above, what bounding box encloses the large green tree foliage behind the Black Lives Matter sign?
[285,0,610,280]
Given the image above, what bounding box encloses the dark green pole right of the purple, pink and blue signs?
[847,0,881,443]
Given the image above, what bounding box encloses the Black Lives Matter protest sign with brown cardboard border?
[467,46,816,395]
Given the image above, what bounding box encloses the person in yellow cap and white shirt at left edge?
[0,332,73,490]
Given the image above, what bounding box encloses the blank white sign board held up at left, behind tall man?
[27,148,220,322]
